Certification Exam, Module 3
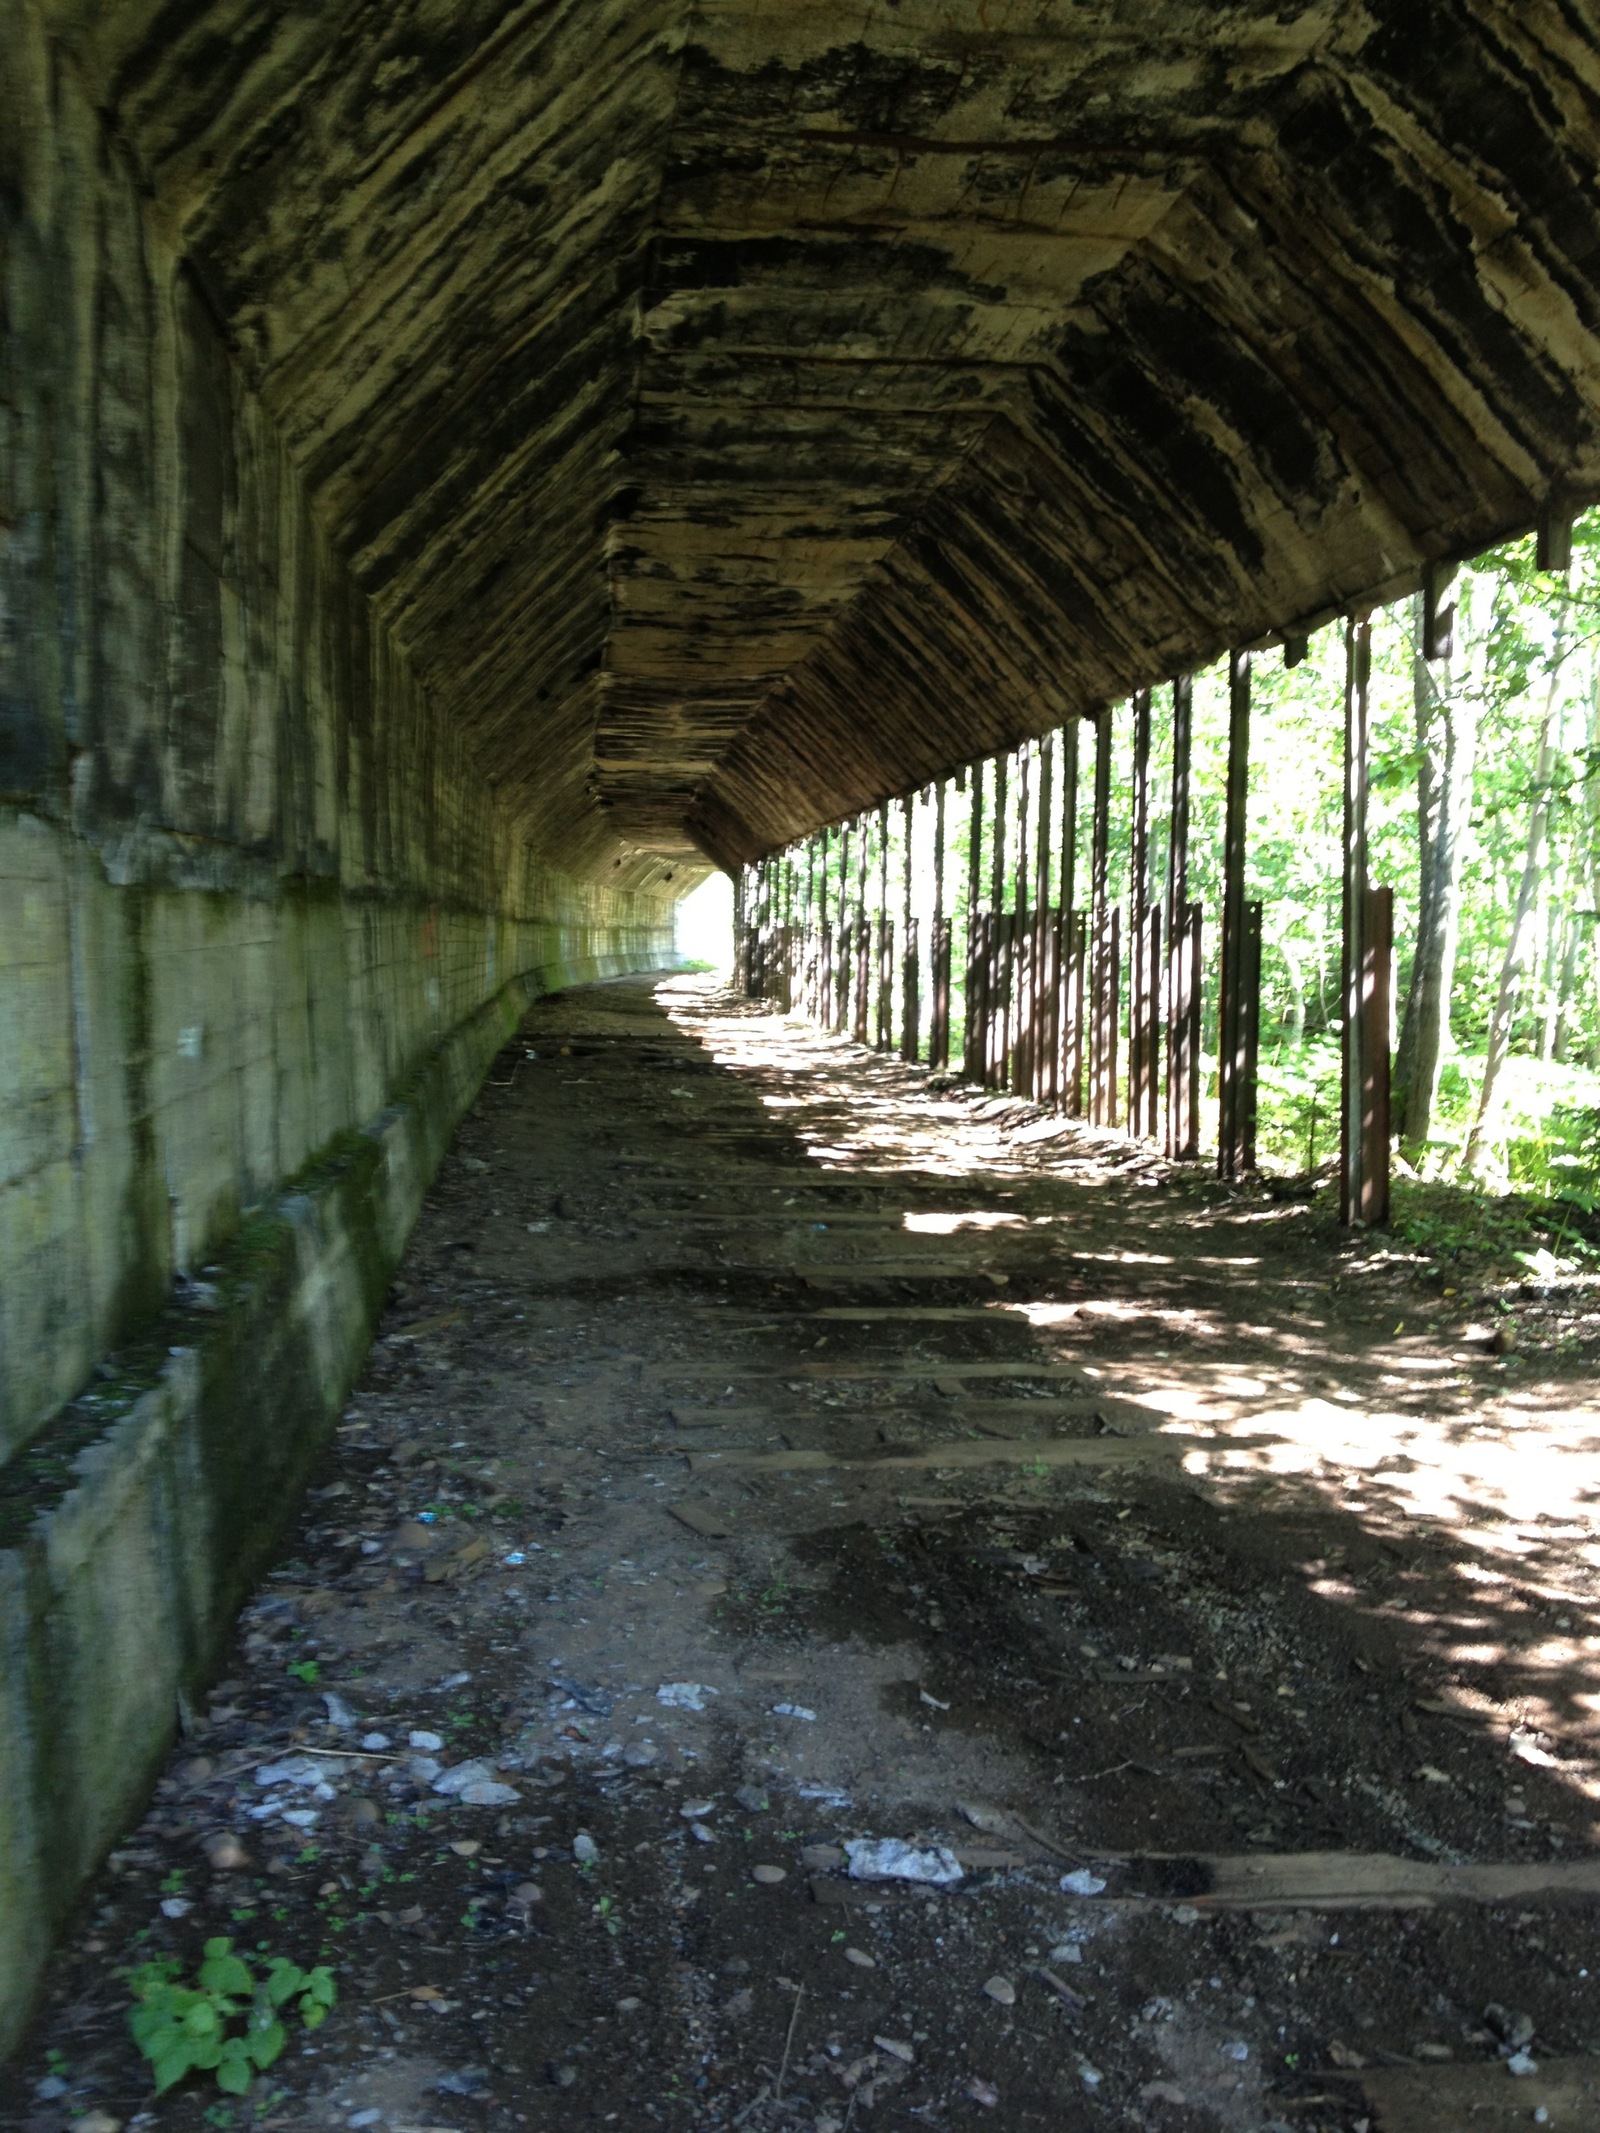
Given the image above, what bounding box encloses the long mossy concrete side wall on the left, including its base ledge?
[0,16,672,2050]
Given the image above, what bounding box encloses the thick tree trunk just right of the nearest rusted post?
[1395,595,1478,1162]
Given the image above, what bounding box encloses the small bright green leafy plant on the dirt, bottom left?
[128,1939,339,2097]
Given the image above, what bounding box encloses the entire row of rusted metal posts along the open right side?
[734,606,1399,1224]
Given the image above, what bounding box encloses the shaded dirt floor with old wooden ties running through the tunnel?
[0,979,1600,2133]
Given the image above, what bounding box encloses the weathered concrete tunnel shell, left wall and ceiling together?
[0,0,1600,2043]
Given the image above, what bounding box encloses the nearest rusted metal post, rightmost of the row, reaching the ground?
[1340,614,1393,1226]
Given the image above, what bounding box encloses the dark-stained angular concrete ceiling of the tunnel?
[60,0,1600,868]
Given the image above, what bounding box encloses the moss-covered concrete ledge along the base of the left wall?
[0,956,670,2056]
